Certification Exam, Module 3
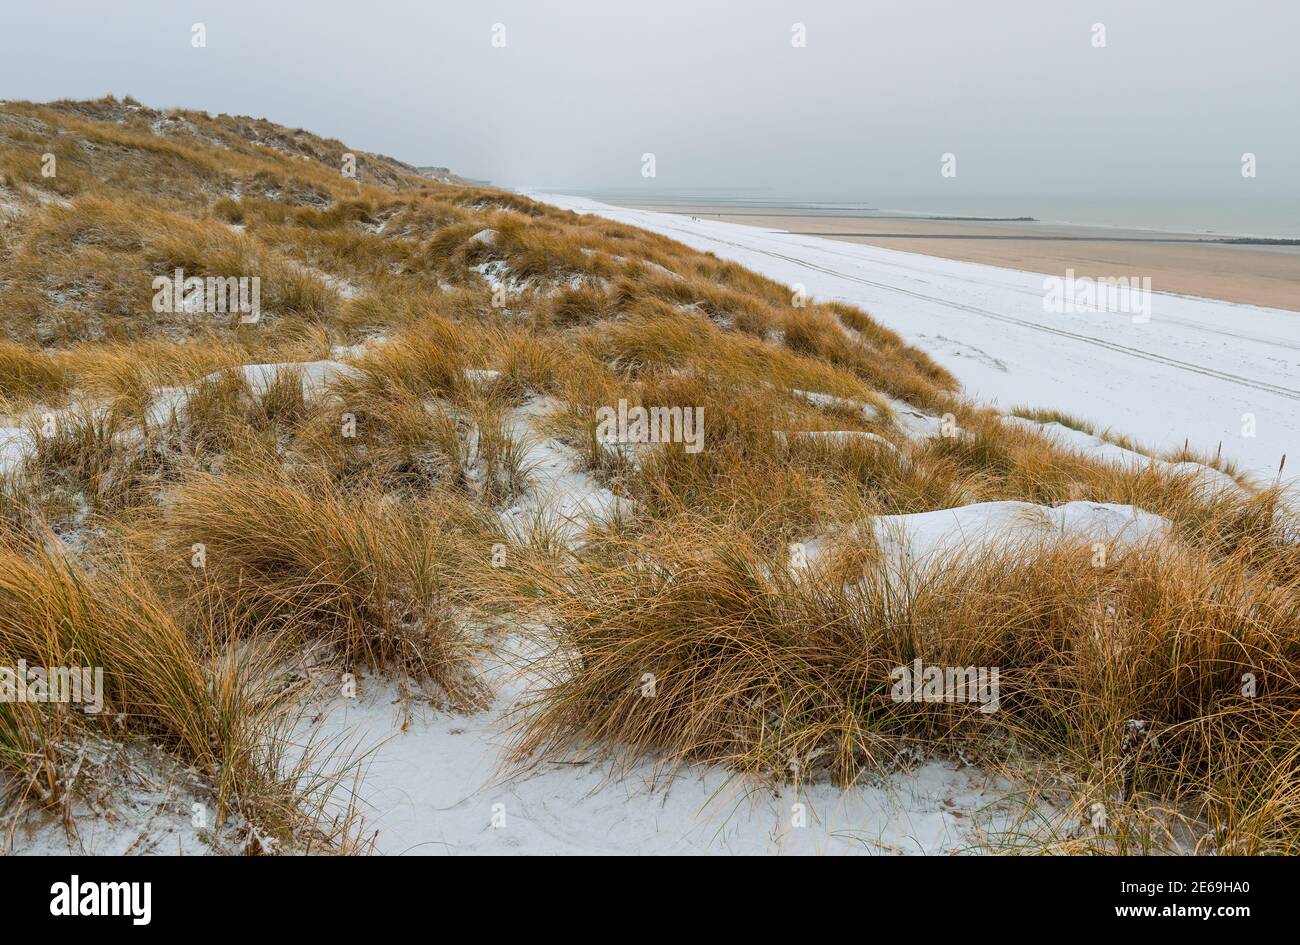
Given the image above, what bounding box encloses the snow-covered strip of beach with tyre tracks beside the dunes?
[529,194,1300,481]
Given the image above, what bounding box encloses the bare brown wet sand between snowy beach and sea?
[628,201,1300,311]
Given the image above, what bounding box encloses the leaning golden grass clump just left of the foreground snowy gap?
[148,455,484,708]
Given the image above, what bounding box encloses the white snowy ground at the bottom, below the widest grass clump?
[306,639,1060,855]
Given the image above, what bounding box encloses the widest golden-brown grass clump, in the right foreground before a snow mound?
[504,516,1300,853]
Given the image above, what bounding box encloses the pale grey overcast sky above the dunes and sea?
[0,0,1300,201]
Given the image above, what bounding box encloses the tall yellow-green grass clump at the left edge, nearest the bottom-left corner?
[0,532,356,849]
